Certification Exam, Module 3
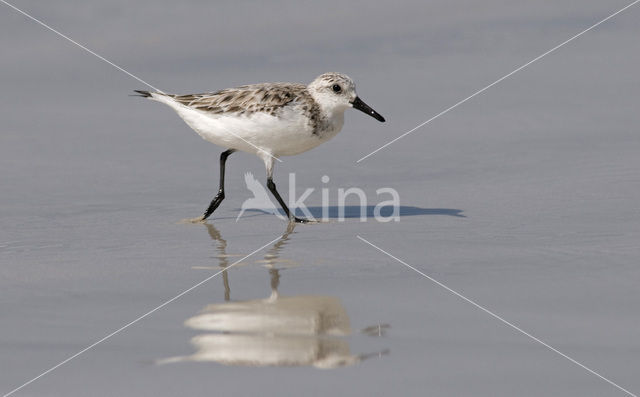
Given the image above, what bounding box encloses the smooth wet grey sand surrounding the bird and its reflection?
[0,0,640,396]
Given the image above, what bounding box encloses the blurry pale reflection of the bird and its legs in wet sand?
[160,223,388,369]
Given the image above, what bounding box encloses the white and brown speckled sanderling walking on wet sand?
[135,73,384,223]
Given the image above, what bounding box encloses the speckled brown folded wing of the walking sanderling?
[170,83,315,115]
